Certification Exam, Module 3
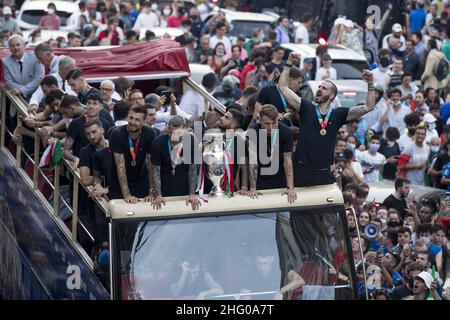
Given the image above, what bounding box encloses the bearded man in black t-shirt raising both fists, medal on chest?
[279,52,376,187]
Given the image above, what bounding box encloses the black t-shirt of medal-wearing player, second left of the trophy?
[109,126,155,199]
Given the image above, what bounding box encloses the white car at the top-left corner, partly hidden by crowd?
[17,0,78,31]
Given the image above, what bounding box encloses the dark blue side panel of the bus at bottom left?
[0,151,109,299]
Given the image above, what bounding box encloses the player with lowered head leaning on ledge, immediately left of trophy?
[151,115,201,210]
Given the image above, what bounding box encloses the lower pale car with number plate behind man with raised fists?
[301,80,367,108]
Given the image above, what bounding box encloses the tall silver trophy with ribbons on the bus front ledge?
[203,132,225,197]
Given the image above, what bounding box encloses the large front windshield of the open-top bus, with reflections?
[114,206,353,300]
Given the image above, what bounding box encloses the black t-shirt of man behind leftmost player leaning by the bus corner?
[67,109,114,157]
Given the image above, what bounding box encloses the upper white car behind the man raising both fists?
[281,43,369,80]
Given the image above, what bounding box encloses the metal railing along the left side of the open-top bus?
[0,88,109,269]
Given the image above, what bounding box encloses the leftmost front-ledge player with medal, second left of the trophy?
[109,106,155,203]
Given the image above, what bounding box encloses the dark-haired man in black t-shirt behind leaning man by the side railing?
[64,93,114,161]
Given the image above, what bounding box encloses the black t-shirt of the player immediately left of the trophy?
[152,133,194,197]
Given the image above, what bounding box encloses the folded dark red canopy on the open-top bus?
[0,40,190,85]
